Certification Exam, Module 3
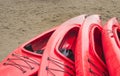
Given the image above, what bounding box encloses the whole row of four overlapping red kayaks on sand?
[0,15,120,76]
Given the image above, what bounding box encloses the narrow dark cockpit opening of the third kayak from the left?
[94,27,106,63]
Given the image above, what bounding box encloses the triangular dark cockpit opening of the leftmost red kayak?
[24,31,54,54]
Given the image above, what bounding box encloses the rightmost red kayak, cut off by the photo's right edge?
[102,18,120,76]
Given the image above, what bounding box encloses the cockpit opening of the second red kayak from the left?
[59,28,79,61]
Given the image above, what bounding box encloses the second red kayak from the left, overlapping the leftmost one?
[38,15,85,76]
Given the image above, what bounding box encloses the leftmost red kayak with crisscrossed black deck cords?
[0,28,56,76]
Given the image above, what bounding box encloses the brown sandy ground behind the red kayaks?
[0,0,120,61]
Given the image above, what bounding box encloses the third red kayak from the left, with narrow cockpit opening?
[75,15,109,76]
